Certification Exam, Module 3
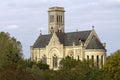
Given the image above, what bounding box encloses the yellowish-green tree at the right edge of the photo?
[104,51,120,80]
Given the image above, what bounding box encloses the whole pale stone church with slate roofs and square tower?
[30,7,106,70]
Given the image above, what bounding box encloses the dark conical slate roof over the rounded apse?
[86,36,105,49]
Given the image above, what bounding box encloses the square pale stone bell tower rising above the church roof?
[48,7,65,34]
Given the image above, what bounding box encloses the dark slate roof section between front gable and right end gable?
[57,30,91,46]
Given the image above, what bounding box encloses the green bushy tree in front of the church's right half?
[57,57,102,80]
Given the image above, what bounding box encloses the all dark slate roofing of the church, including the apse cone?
[33,30,104,49]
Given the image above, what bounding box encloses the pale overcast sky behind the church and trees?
[0,0,120,58]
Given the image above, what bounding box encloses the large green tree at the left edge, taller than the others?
[0,32,32,80]
